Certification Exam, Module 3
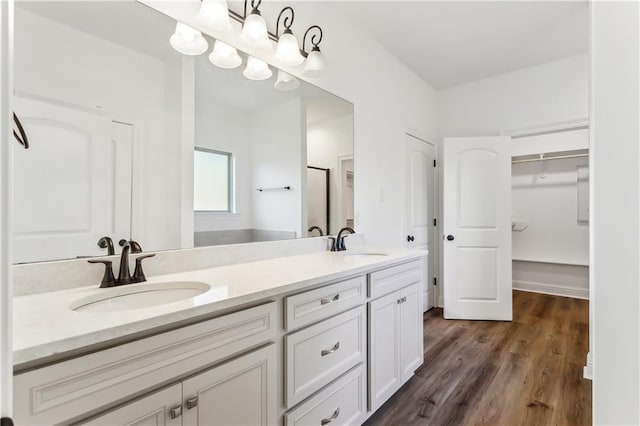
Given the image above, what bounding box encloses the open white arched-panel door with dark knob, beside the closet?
[443,137,512,321]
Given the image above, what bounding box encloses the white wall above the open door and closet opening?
[438,53,589,137]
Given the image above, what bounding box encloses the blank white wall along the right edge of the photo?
[591,1,640,425]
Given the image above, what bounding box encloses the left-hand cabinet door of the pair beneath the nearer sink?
[78,383,182,426]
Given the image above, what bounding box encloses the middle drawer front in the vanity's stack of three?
[285,307,367,408]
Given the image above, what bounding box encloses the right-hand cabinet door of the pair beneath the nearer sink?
[183,344,281,426]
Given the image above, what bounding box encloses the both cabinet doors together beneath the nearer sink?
[77,344,277,426]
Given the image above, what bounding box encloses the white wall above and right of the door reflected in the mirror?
[15,8,181,250]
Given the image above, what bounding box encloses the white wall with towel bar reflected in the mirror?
[250,98,307,237]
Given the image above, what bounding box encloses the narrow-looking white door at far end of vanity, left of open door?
[405,134,437,311]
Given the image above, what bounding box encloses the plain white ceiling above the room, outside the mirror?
[324,0,589,89]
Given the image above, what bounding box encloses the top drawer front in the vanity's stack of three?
[284,276,366,331]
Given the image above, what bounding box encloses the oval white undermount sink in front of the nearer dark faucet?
[69,281,211,312]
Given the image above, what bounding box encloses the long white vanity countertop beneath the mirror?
[13,248,427,365]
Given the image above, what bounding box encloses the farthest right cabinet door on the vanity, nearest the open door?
[399,284,424,383]
